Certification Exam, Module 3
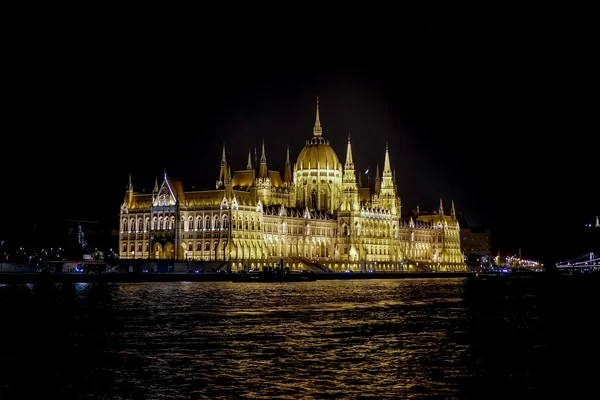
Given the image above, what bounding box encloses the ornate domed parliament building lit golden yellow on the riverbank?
[119,101,466,272]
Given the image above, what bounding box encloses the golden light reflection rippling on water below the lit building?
[106,280,478,398]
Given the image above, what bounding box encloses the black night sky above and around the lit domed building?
[2,19,600,266]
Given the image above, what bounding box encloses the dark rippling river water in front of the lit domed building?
[0,278,596,399]
